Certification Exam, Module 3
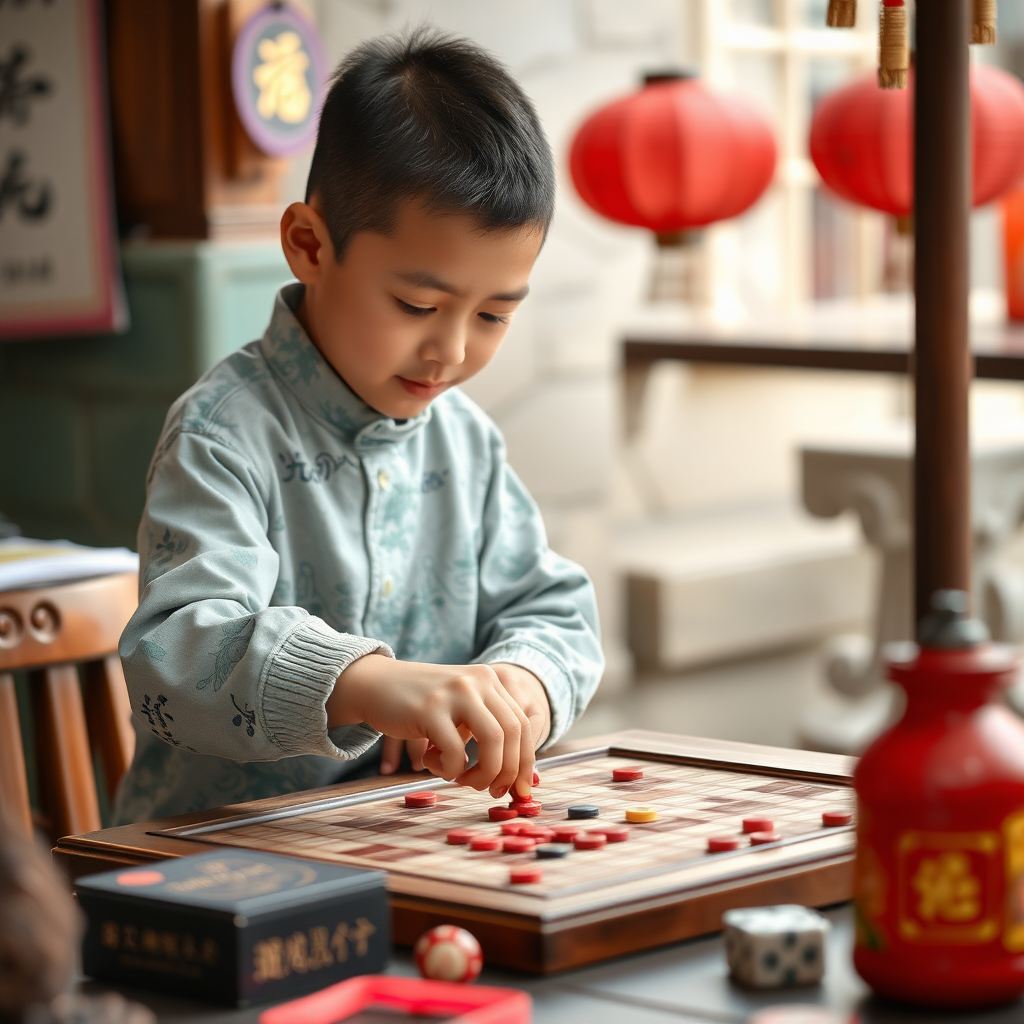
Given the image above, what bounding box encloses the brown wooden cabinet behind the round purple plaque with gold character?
[106,0,288,240]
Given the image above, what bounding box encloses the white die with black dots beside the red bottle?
[722,903,831,988]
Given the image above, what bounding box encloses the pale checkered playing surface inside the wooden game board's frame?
[184,757,854,896]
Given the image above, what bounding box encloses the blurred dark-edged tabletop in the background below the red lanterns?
[624,296,1024,380]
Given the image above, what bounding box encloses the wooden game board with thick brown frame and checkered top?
[153,733,854,972]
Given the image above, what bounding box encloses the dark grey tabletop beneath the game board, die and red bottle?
[81,905,1024,1024]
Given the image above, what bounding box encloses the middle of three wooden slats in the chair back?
[30,665,100,842]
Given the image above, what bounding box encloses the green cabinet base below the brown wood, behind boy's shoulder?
[0,241,292,548]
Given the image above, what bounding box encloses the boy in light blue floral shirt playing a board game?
[116,32,602,821]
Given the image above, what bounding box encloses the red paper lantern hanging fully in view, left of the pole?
[569,77,775,233]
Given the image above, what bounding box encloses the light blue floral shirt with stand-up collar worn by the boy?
[115,285,602,821]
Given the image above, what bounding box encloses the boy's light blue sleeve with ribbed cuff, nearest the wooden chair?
[120,431,391,761]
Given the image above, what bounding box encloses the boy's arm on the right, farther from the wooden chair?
[474,441,604,743]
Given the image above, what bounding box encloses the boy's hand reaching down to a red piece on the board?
[327,654,535,799]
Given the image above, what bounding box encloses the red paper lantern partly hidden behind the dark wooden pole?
[811,65,1024,217]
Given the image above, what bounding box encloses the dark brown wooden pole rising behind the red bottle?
[913,0,973,623]
